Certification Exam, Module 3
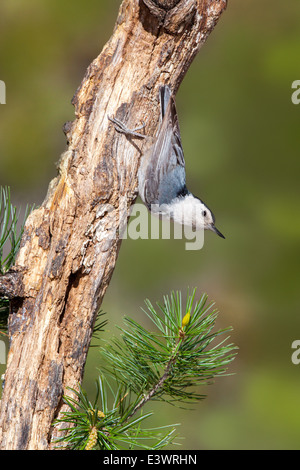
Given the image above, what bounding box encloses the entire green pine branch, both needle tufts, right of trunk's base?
[56,290,236,450]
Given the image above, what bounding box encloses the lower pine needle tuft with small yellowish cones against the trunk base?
[55,376,175,450]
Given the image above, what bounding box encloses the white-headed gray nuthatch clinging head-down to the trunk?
[109,85,225,238]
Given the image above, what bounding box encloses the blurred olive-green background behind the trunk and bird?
[0,0,300,449]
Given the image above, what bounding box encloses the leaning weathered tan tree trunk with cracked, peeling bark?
[0,0,227,449]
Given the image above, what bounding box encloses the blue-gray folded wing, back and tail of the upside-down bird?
[139,87,186,208]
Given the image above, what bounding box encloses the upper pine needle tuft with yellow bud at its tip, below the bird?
[102,292,234,401]
